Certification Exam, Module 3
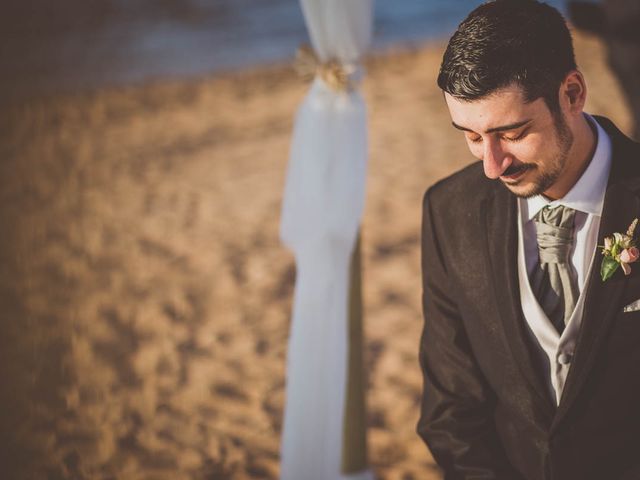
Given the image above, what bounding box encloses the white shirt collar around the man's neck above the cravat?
[520,113,611,221]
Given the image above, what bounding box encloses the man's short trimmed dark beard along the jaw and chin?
[503,112,573,198]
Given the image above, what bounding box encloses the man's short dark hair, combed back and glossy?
[438,0,577,114]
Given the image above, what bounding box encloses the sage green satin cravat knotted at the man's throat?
[531,205,580,334]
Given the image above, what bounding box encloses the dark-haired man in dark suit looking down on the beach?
[418,0,640,480]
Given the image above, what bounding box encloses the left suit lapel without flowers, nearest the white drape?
[482,186,555,418]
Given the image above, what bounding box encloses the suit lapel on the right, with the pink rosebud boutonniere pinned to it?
[551,118,640,430]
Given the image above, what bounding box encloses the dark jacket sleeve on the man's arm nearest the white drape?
[417,190,522,480]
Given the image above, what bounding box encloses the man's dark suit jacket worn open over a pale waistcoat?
[418,117,640,480]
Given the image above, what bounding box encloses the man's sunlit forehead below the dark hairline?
[445,85,550,133]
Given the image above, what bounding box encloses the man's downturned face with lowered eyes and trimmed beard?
[445,85,573,197]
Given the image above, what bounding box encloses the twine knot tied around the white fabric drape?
[294,45,363,92]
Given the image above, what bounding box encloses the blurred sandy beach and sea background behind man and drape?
[0,0,640,480]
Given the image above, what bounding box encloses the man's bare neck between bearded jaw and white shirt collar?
[544,114,597,200]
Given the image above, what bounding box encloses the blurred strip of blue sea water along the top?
[0,0,565,96]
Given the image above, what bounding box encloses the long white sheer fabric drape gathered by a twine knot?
[280,0,373,480]
